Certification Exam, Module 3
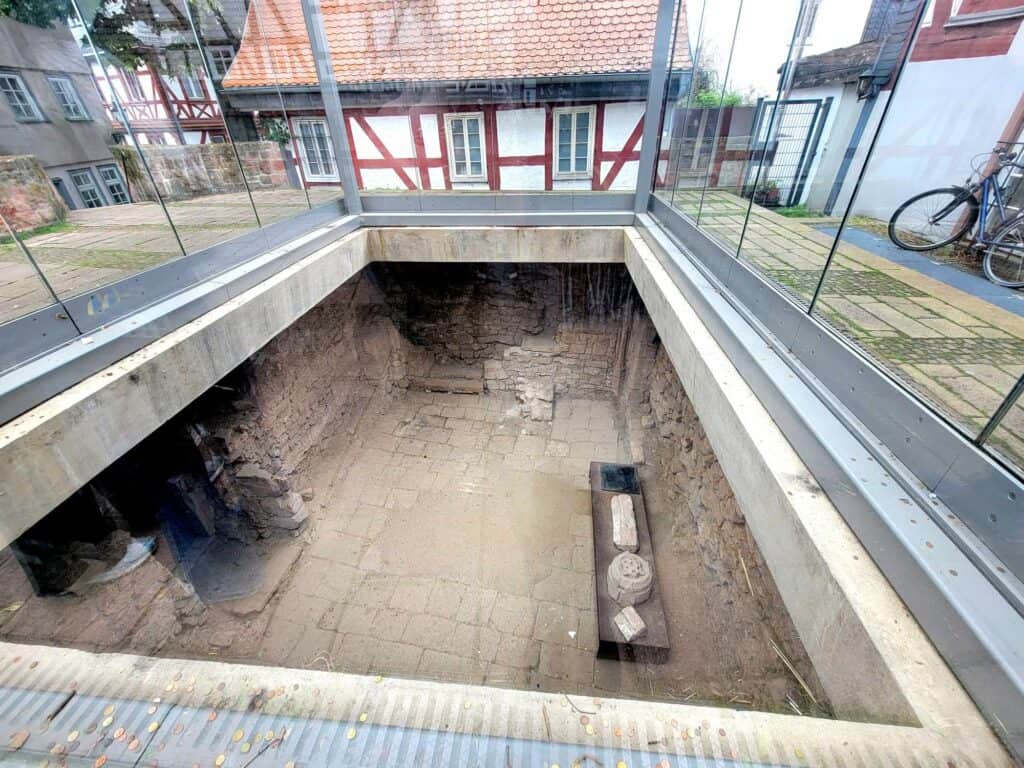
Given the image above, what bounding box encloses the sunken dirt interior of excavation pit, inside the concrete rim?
[0,264,828,715]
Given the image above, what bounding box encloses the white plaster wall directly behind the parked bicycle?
[854,28,1024,219]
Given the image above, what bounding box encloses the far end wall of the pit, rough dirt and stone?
[370,263,639,399]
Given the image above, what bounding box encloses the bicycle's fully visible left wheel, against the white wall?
[889,186,978,251]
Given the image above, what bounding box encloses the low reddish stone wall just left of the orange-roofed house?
[115,141,289,202]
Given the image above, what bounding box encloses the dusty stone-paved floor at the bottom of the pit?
[0,392,824,713]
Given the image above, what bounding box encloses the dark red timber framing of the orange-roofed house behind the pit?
[274,101,668,191]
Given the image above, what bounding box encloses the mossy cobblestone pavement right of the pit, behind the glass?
[673,189,1024,473]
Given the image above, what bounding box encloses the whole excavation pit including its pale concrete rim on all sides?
[0,227,1005,765]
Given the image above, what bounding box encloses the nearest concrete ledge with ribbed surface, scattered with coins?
[0,643,1012,768]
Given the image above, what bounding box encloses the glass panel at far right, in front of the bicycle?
[811,3,1024,466]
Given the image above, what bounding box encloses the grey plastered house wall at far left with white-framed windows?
[0,17,112,173]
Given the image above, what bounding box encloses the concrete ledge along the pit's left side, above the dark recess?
[0,230,367,547]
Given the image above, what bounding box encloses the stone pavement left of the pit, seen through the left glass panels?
[0,187,339,323]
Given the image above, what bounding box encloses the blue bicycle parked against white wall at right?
[889,146,1024,288]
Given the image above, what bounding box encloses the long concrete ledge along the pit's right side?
[626,231,1009,760]
